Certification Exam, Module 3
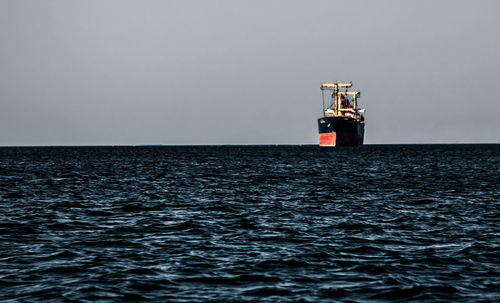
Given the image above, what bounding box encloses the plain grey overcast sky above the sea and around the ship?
[0,0,500,145]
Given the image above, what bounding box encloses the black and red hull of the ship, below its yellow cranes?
[318,116,365,146]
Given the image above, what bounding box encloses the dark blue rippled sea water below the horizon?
[0,145,500,302]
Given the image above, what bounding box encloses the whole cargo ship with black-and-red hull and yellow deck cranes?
[318,82,365,146]
